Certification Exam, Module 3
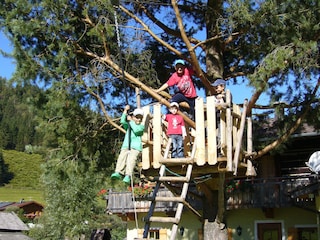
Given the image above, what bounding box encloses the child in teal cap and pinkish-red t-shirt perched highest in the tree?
[155,59,197,120]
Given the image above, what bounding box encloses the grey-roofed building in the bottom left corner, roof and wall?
[0,212,31,240]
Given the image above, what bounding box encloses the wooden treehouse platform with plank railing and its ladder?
[119,90,255,240]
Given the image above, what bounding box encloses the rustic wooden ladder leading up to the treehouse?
[143,139,200,240]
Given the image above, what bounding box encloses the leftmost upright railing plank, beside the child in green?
[141,105,151,170]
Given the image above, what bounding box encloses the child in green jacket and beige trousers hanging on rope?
[111,105,144,184]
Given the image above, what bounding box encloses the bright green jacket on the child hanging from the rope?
[120,113,144,152]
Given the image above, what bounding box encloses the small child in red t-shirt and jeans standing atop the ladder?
[163,102,187,158]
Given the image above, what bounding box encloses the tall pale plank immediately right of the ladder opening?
[195,97,206,166]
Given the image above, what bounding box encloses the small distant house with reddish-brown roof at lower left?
[0,200,44,219]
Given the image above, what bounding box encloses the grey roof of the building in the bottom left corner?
[0,212,29,232]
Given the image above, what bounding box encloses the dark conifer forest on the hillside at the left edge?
[0,79,45,151]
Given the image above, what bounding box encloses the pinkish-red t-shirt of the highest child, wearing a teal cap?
[167,68,197,98]
